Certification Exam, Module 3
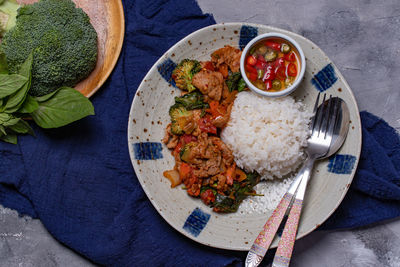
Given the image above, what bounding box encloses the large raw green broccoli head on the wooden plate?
[0,0,97,96]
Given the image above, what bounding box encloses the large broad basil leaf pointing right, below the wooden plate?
[31,87,94,128]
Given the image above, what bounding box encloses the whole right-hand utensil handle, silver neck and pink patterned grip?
[272,159,314,267]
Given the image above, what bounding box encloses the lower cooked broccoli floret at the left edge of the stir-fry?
[169,104,194,135]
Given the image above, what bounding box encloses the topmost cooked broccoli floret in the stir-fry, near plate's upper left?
[172,59,201,92]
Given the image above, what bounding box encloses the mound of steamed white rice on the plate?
[221,92,311,180]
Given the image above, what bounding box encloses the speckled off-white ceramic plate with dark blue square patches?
[128,23,361,250]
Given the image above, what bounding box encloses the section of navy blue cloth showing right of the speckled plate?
[321,111,400,229]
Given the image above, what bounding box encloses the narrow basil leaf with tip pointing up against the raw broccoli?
[4,54,33,113]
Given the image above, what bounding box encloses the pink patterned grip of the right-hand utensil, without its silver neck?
[272,198,303,267]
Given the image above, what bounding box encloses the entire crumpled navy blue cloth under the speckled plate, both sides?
[0,0,400,266]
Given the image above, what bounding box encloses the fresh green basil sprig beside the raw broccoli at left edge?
[0,54,94,144]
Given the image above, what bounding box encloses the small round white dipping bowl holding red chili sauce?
[240,32,306,97]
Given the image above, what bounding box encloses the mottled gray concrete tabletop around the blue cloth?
[0,0,400,267]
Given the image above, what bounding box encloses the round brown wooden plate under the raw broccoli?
[18,0,125,97]
